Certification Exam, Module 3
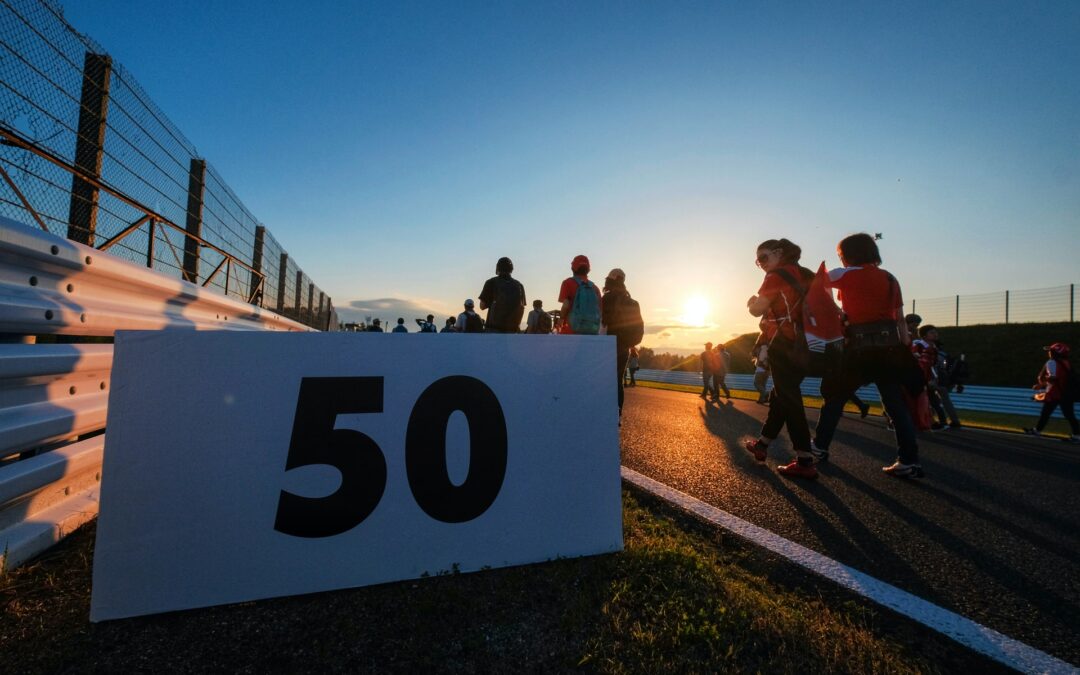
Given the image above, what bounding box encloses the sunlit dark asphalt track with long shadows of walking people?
[622,387,1080,664]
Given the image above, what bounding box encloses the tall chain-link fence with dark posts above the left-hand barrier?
[0,0,337,329]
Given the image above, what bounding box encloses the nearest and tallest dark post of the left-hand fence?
[68,52,112,246]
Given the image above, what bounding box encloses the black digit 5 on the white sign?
[274,377,387,538]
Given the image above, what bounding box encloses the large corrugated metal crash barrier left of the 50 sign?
[0,217,311,570]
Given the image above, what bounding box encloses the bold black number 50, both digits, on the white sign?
[274,376,508,538]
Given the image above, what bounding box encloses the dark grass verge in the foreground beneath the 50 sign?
[0,489,1001,673]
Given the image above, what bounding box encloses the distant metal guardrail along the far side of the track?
[636,369,1062,417]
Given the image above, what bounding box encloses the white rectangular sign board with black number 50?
[91,332,622,621]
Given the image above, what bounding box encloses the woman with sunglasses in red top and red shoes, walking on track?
[746,239,818,478]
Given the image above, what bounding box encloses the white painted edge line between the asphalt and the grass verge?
[622,467,1080,673]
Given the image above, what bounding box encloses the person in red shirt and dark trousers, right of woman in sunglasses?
[812,232,922,477]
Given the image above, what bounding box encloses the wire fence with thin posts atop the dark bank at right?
[910,284,1077,326]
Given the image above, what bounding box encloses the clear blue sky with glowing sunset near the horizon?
[64,0,1080,349]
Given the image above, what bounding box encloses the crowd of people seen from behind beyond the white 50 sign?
[349,255,643,415]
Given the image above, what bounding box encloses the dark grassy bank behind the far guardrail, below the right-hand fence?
[672,322,1080,387]
